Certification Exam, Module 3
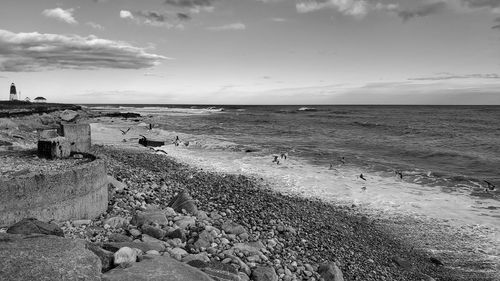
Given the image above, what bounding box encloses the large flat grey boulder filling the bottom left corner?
[0,233,101,281]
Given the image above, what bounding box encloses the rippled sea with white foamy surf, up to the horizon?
[86,105,500,266]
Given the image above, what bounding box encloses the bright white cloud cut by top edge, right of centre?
[295,0,369,17]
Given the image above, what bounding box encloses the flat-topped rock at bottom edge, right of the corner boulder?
[102,256,213,281]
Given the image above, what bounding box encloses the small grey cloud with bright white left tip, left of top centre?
[120,10,191,28]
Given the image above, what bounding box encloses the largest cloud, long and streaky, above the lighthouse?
[0,29,167,72]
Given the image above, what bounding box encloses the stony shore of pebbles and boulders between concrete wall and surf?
[50,144,493,280]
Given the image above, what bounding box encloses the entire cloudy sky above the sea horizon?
[0,0,500,104]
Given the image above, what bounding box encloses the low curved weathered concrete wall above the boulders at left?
[0,160,108,226]
